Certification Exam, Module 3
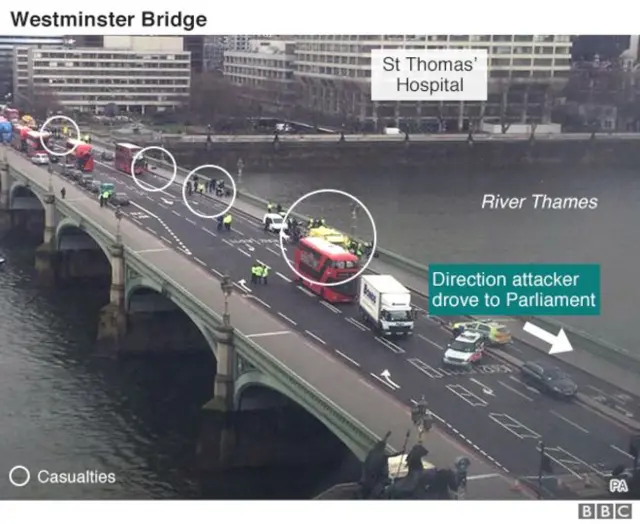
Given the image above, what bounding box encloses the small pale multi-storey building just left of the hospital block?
[224,39,296,108]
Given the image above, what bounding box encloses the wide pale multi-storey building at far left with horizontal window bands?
[14,36,191,113]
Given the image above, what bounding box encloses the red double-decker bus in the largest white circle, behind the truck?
[294,237,360,303]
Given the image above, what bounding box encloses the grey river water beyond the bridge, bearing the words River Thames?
[242,166,640,352]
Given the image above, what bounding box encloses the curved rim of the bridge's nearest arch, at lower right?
[233,370,363,458]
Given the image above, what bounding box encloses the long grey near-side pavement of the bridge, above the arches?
[8,147,529,499]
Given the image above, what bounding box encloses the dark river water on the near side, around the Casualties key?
[0,243,354,499]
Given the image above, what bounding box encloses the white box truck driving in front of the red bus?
[358,275,415,336]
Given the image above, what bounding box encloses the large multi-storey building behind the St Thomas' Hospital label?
[293,35,571,130]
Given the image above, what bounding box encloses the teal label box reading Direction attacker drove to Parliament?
[429,264,600,316]
